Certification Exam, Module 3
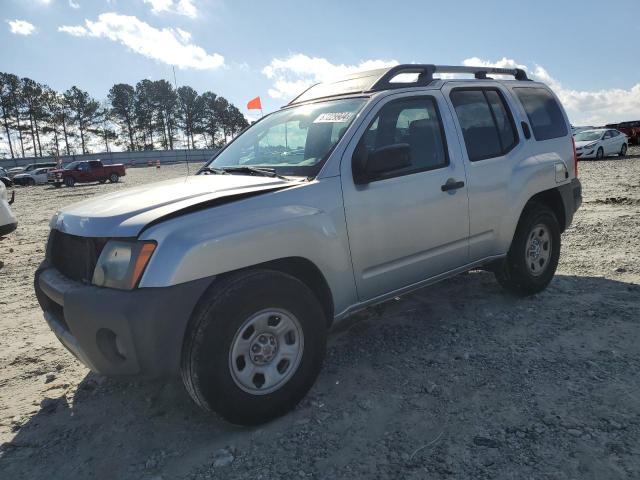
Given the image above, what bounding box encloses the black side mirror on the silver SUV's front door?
[352,143,411,185]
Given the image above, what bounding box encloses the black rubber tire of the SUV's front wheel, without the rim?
[181,270,327,425]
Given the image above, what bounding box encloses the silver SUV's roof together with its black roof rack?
[289,64,529,105]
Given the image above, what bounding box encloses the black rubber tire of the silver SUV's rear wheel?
[495,203,560,296]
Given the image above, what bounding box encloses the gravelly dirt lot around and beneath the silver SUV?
[0,148,640,480]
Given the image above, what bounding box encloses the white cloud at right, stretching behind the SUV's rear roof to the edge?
[462,57,640,125]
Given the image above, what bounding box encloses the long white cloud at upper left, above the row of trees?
[58,12,224,70]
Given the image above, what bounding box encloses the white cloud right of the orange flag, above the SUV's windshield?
[262,53,398,100]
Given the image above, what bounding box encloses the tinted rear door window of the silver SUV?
[451,89,518,162]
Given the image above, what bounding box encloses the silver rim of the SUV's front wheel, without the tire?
[229,308,304,395]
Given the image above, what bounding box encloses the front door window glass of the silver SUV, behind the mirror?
[357,97,448,176]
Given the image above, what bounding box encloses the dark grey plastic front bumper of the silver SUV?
[35,260,212,377]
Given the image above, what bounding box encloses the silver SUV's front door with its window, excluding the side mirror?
[341,92,469,301]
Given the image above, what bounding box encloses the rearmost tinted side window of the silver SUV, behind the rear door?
[514,87,567,140]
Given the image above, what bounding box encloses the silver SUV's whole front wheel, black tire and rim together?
[181,270,327,425]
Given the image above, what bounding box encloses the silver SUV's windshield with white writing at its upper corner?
[206,98,366,177]
